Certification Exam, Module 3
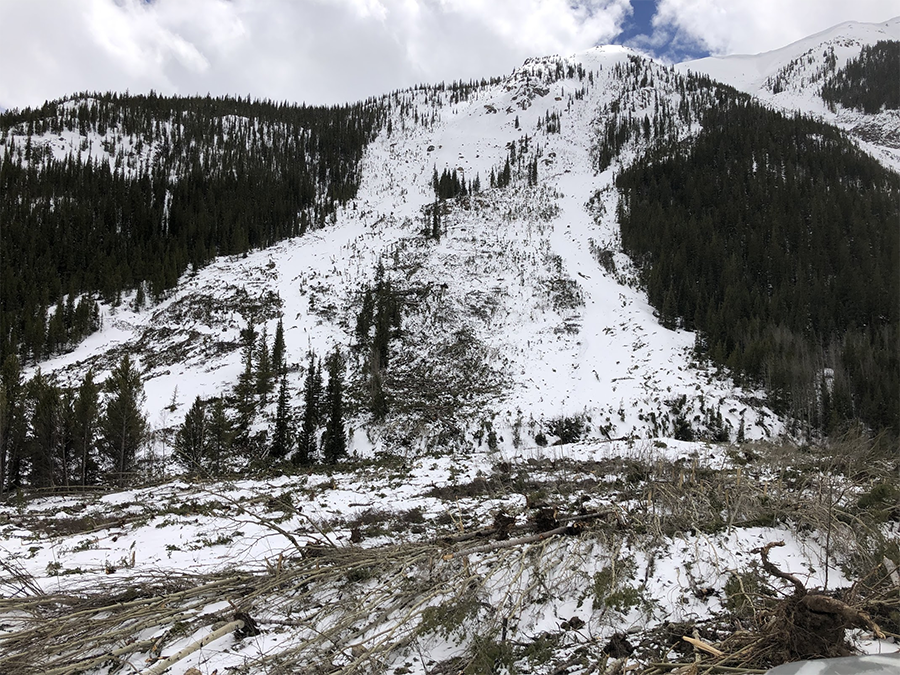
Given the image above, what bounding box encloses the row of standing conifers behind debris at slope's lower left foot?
[0,314,356,495]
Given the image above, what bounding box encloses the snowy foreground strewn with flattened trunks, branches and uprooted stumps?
[0,438,900,675]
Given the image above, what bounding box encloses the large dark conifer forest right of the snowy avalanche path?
[617,97,900,430]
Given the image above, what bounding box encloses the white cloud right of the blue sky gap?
[653,0,900,55]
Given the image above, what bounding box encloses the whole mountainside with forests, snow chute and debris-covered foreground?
[0,22,900,675]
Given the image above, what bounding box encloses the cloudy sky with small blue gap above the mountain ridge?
[0,0,900,108]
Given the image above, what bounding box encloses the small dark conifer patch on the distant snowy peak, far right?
[822,41,900,115]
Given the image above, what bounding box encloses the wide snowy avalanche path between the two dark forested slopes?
[31,47,782,460]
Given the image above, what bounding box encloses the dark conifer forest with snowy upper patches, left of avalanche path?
[0,93,384,359]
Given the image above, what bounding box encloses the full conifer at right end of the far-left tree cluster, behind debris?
[100,354,147,485]
